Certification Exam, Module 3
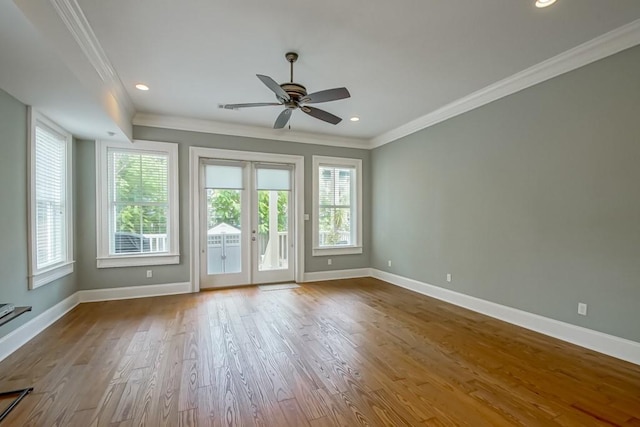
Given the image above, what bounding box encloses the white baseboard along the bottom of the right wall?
[371,268,640,365]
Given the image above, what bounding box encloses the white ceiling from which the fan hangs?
[0,0,640,145]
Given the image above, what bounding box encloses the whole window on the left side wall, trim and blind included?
[29,109,74,289]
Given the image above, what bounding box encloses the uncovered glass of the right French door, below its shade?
[257,190,291,271]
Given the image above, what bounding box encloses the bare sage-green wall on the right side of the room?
[371,47,640,341]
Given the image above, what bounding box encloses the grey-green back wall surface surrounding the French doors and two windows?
[77,126,371,289]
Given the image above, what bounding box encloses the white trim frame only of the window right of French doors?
[312,156,362,256]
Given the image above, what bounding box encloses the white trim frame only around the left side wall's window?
[28,107,75,289]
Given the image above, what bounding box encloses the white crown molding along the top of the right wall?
[369,19,640,149]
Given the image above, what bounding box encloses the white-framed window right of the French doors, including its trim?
[313,156,362,256]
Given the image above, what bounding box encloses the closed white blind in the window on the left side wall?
[34,125,67,269]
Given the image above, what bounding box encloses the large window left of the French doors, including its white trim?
[96,141,180,268]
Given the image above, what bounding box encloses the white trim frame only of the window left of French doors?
[96,140,180,268]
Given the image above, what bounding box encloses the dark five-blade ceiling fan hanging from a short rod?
[220,52,351,129]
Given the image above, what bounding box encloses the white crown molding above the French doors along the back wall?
[133,113,370,149]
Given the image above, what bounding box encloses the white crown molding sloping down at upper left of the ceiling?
[49,0,135,116]
